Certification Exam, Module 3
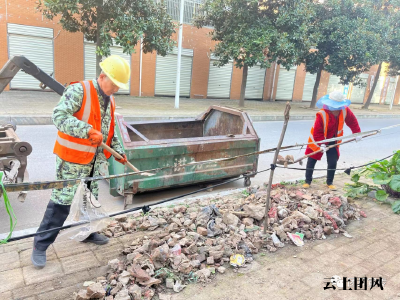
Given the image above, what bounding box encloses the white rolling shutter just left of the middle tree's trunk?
[207,58,233,98]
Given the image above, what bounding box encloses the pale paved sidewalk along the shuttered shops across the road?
[0,91,400,125]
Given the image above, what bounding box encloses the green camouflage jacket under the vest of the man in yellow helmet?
[52,79,124,160]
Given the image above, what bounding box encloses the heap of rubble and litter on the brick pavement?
[75,184,366,300]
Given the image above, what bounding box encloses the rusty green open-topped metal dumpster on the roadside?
[109,106,260,206]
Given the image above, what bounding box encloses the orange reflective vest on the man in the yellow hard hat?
[53,80,115,165]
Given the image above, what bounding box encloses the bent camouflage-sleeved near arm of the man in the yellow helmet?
[52,83,92,139]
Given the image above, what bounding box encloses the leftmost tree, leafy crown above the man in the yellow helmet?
[38,0,175,73]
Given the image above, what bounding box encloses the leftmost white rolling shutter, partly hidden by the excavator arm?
[7,23,54,90]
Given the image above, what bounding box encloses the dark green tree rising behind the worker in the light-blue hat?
[300,0,387,107]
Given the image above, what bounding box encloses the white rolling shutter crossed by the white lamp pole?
[154,48,193,97]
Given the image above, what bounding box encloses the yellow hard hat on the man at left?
[100,55,131,90]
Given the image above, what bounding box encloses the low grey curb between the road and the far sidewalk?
[0,115,400,125]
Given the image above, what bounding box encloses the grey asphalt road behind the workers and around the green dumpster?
[0,119,400,234]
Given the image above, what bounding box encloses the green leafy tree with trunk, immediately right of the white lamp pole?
[194,0,315,106]
